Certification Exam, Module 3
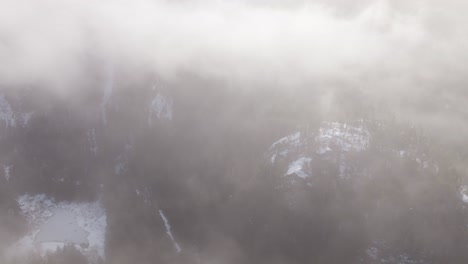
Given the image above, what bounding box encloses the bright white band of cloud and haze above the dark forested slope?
[0,0,468,88]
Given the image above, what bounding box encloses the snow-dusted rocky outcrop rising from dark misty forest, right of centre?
[268,120,442,185]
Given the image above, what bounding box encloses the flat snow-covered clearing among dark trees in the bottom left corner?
[7,195,106,260]
